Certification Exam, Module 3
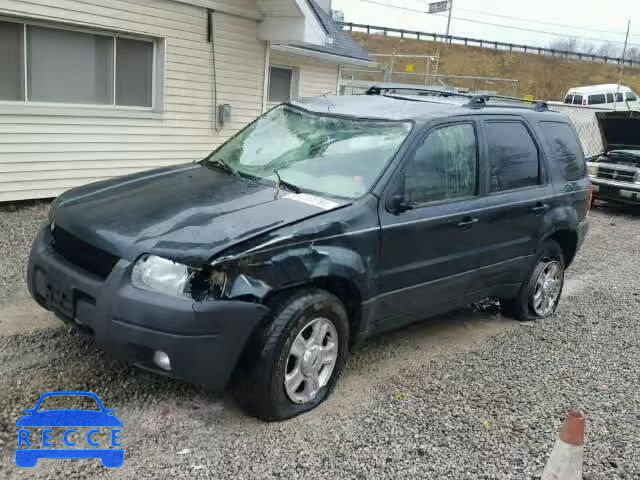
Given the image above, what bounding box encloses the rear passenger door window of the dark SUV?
[485,122,540,193]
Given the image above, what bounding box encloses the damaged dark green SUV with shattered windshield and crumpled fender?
[28,92,589,420]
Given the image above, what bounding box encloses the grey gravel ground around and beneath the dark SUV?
[0,207,640,479]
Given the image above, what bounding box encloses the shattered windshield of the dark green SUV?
[207,105,411,198]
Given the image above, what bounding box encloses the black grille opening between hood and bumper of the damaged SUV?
[53,227,118,278]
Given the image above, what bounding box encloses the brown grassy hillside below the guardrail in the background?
[352,32,640,100]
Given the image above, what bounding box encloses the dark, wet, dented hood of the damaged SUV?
[54,164,347,266]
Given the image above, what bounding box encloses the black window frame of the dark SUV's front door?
[385,118,486,210]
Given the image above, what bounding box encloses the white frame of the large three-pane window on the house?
[0,15,159,112]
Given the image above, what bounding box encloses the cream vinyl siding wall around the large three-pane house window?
[0,0,266,201]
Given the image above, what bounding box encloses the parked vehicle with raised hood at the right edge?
[587,112,640,204]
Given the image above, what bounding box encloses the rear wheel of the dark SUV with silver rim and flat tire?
[500,240,564,320]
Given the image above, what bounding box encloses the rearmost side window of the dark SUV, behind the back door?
[540,122,587,182]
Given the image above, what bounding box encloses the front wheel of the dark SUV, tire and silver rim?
[234,289,349,421]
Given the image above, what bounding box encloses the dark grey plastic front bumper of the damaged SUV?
[27,227,269,388]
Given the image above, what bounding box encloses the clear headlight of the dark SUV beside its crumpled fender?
[131,255,195,298]
